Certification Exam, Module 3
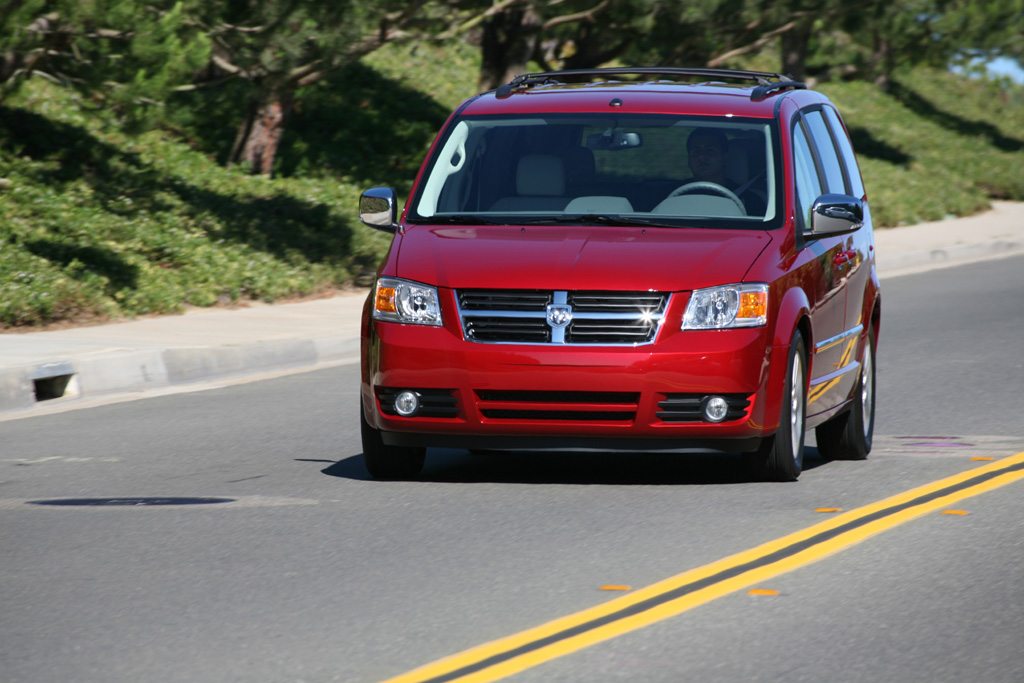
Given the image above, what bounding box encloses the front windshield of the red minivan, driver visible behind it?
[408,114,781,229]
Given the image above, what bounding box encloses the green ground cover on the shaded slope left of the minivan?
[0,77,386,326]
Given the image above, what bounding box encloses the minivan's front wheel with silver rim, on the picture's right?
[743,331,807,481]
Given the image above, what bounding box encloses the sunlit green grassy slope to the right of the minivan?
[819,69,1024,226]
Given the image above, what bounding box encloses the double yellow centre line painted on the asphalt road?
[385,453,1024,683]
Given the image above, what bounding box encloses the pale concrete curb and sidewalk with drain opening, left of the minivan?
[0,292,366,418]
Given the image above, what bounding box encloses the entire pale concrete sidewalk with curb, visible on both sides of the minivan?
[0,202,1024,420]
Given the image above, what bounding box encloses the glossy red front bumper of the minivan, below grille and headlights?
[361,301,786,451]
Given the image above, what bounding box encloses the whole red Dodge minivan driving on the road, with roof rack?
[359,68,881,480]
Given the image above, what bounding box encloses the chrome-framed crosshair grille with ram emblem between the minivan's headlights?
[457,290,670,346]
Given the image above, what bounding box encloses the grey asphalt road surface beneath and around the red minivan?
[0,257,1024,683]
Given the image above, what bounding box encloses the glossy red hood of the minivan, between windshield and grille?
[395,225,771,292]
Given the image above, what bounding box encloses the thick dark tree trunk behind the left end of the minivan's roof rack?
[479,7,541,91]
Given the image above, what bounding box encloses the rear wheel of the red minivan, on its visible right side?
[814,328,874,460]
